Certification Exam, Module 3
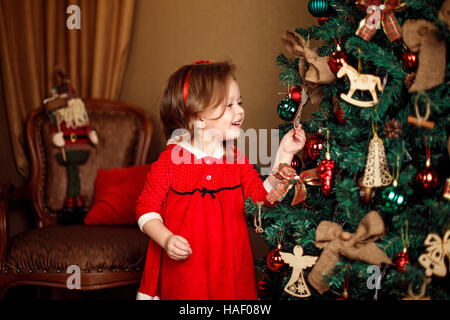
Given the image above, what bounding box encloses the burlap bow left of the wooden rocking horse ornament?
[281,31,336,105]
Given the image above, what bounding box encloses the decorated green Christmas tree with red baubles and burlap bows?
[246,0,450,300]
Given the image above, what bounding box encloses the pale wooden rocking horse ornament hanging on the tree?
[337,62,383,108]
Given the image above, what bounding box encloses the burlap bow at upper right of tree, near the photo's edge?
[402,19,446,92]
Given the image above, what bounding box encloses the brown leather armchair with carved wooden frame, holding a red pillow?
[0,99,152,299]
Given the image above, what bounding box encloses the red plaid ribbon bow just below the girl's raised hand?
[266,163,320,206]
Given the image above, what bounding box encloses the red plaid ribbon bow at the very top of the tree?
[356,0,405,42]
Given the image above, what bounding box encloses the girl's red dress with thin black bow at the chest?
[136,144,271,300]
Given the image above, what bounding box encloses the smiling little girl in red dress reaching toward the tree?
[136,61,305,300]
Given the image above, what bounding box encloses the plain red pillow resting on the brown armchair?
[84,164,151,225]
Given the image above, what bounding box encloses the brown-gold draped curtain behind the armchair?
[0,0,135,177]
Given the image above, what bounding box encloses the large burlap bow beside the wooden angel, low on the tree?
[308,211,392,294]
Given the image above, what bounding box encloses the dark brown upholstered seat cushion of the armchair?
[6,225,149,273]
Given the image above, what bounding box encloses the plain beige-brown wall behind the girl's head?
[120,0,315,161]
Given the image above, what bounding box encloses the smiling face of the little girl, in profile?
[197,79,245,141]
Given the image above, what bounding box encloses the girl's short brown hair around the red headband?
[160,62,235,139]
